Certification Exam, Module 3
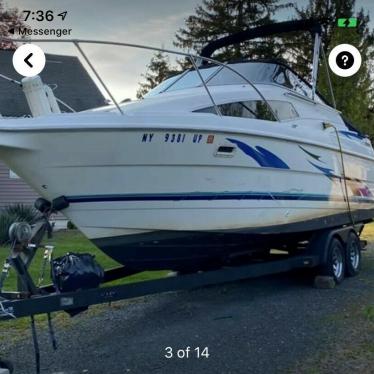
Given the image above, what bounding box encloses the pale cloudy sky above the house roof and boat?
[4,0,374,101]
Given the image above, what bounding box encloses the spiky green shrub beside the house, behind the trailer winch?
[0,204,39,244]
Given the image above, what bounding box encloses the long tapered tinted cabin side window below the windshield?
[195,100,298,121]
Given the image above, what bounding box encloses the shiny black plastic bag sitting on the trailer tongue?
[51,253,104,292]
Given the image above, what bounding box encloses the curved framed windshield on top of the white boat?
[145,61,320,99]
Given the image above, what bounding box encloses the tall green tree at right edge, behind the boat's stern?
[288,0,374,138]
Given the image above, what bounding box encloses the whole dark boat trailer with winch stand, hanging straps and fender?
[0,199,365,374]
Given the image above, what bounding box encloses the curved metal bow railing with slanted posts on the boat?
[0,37,279,121]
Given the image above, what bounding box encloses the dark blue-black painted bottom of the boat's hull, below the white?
[92,209,374,272]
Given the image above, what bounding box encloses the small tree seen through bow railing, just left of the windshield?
[136,52,173,99]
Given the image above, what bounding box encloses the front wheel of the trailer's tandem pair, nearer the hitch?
[321,238,345,284]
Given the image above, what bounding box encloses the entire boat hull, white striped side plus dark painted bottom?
[0,116,374,270]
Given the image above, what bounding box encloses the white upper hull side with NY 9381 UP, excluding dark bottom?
[0,114,374,238]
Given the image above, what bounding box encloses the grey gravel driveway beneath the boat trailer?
[1,250,374,374]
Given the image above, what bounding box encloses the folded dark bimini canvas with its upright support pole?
[201,19,322,100]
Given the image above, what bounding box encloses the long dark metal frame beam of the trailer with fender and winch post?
[0,225,363,320]
